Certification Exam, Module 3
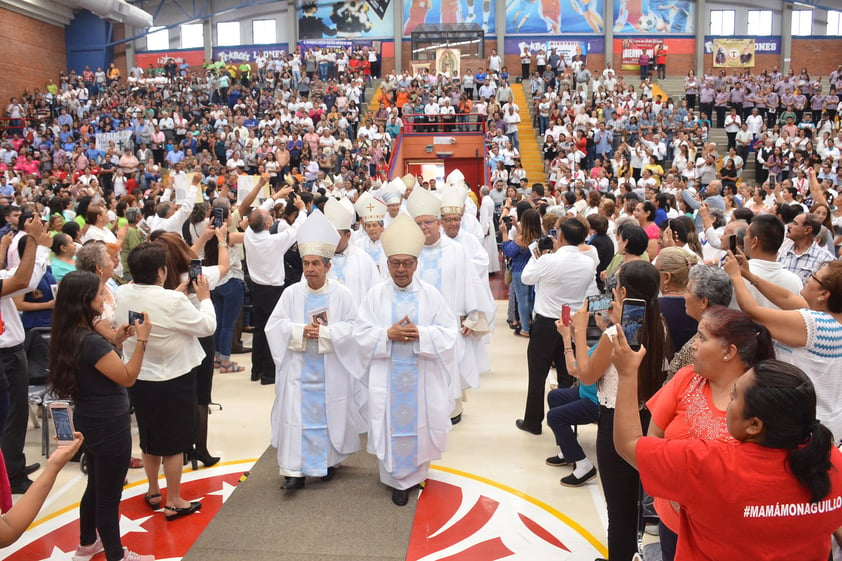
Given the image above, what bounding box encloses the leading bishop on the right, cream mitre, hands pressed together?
[354,214,460,506]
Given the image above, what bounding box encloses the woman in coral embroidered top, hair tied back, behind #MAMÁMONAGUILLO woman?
[646,306,775,561]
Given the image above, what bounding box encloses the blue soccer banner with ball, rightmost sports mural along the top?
[613,0,696,35]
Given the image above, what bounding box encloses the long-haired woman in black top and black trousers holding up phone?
[49,271,154,561]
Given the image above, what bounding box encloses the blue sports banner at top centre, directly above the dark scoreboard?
[396,0,496,35]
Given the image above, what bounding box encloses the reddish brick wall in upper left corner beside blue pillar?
[0,9,67,109]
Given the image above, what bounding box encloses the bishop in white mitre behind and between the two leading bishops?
[324,199,382,302]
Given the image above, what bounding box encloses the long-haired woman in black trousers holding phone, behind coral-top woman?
[571,261,669,559]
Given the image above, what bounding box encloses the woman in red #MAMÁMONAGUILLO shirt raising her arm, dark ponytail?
[612,330,842,561]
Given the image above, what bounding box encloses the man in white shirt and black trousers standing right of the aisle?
[515,220,597,434]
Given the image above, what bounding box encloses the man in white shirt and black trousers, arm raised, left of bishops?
[244,197,307,385]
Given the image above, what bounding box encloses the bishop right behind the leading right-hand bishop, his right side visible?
[407,188,489,410]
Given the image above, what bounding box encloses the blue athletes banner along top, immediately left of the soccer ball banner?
[506,0,605,35]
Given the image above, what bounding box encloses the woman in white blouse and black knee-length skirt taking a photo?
[115,243,216,521]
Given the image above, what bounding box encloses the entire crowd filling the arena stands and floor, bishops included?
[0,50,842,561]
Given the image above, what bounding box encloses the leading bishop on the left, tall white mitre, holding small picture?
[266,210,364,490]
